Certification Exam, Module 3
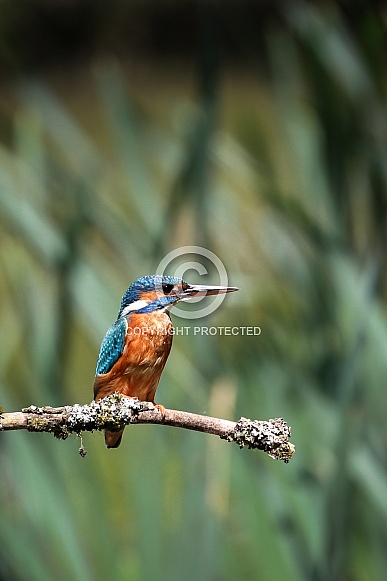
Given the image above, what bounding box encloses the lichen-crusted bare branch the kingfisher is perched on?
[0,394,295,463]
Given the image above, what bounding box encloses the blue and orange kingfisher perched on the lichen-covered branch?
[94,275,238,448]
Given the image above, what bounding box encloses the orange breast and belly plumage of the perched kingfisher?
[94,311,172,402]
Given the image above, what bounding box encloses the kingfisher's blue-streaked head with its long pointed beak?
[118,274,238,317]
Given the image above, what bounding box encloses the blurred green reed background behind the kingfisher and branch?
[0,0,387,581]
